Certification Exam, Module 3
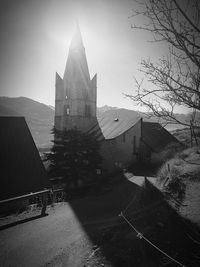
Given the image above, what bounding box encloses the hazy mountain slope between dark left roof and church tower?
[0,97,54,148]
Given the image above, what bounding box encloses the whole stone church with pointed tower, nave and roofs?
[55,26,178,170]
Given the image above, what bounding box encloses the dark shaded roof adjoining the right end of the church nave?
[142,122,178,152]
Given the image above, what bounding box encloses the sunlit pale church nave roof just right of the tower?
[89,109,140,140]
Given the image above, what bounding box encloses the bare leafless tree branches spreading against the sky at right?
[127,0,200,130]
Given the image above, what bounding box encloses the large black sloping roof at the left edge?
[0,117,49,200]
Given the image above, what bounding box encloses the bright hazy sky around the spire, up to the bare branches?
[0,0,184,109]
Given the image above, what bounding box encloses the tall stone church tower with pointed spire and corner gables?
[55,25,97,131]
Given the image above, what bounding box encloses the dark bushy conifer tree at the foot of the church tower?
[46,128,101,187]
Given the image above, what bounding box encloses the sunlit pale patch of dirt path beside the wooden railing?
[0,203,99,267]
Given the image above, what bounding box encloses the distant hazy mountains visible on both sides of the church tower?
[0,97,195,149]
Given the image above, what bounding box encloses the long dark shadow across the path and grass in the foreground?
[69,173,199,267]
